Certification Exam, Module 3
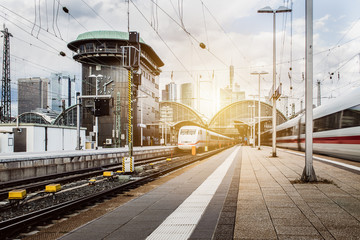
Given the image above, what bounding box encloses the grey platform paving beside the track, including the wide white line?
[61,147,241,240]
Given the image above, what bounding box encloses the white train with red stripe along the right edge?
[262,88,360,161]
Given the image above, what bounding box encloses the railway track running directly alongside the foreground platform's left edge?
[0,149,228,239]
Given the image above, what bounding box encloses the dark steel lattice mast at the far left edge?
[0,24,12,122]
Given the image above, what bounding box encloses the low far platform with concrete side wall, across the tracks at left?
[0,146,177,182]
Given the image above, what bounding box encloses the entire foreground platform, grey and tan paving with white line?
[25,146,360,240]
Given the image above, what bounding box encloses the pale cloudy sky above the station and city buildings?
[0,0,360,117]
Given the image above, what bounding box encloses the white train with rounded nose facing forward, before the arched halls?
[178,126,234,150]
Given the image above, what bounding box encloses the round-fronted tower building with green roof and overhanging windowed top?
[68,31,164,147]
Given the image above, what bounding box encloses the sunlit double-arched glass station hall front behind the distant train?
[160,100,287,144]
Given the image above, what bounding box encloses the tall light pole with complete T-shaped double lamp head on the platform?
[258,6,291,157]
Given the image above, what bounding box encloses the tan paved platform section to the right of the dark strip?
[234,147,360,239]
